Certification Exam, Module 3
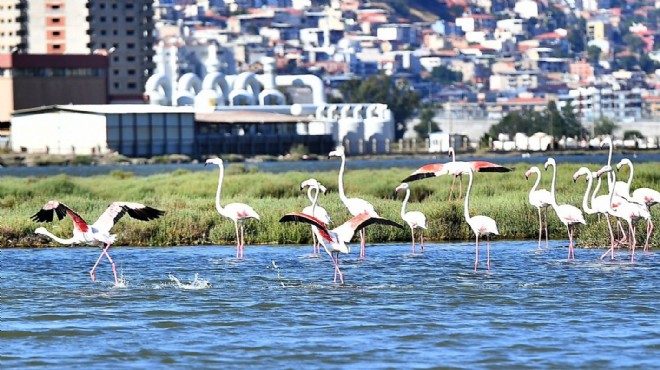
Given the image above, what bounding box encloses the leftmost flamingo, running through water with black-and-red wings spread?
[32,200,165,285]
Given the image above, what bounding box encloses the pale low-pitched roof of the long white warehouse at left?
[13,104,195,116]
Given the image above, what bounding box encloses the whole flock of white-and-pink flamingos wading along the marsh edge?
[32,139,660,285]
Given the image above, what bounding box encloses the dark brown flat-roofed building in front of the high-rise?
[0,54,109,123]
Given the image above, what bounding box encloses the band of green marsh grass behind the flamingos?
[0,159,660,248]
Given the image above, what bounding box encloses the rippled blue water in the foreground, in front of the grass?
[0,241,660,369]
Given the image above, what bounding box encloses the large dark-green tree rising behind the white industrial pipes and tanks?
[339,74,421,138]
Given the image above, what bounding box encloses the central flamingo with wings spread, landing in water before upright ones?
[280,212,403,284]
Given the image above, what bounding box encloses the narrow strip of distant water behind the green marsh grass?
[0,152,660,177]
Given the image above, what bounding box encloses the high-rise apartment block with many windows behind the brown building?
[0,0,154,103]
